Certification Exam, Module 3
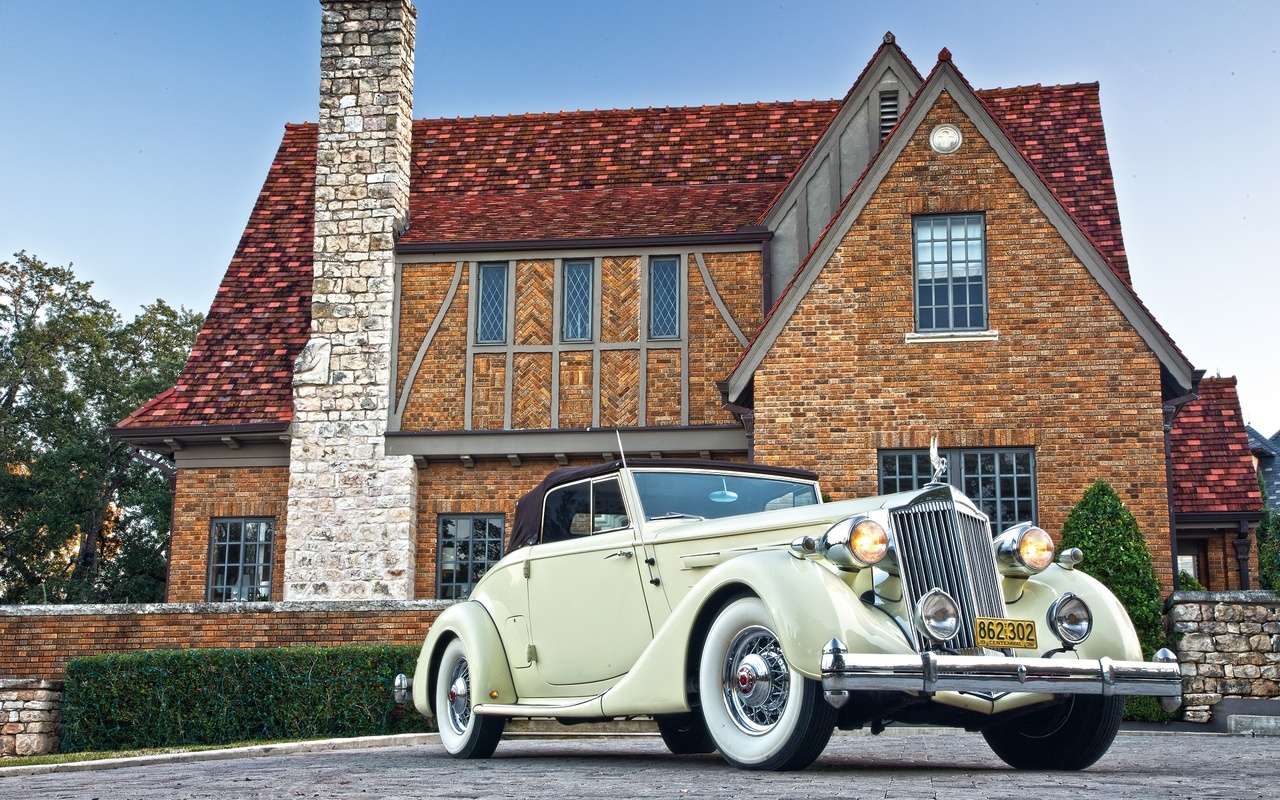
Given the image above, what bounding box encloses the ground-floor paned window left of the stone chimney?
[209,517,275,603]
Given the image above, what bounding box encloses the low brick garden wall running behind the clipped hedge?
[0,600,444,680]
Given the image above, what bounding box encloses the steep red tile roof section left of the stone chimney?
[118,124,316,431]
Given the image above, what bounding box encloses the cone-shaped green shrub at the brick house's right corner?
[1060,480,1174,722]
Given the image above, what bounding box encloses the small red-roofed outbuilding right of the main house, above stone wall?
[1169,378,1262,591]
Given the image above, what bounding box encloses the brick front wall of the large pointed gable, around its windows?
[755,95,1171,586]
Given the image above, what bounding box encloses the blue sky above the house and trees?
[0,0,1280,435]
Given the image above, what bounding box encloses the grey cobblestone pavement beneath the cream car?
[0,733,1280,800]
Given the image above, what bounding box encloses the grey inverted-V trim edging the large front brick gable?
[726,50,1192,402]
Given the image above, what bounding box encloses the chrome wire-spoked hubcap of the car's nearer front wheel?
[723,626,791,733]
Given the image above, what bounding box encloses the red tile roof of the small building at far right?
[1169,378,1262,515]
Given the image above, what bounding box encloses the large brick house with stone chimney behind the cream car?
[113,0,1197,603]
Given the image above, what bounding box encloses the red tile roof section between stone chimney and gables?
[399,100,840,244]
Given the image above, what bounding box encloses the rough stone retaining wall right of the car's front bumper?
[1165,591,1280,722]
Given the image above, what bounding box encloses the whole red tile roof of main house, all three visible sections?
[119,74,1128,430]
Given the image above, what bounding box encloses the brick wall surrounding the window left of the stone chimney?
[166,467,289,603]
